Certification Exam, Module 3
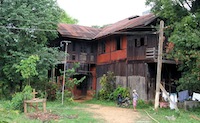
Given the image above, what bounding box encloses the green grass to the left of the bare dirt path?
[0,101,103,123]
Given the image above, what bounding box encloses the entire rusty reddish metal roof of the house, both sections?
[58,14,157,40]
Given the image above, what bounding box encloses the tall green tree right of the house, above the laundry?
[146,0,200,92]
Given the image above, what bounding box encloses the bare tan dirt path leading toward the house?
[84,104,151,123]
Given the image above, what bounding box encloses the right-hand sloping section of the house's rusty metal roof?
[95,14,156,38]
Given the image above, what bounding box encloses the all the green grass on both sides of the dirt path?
[0,99,200,123]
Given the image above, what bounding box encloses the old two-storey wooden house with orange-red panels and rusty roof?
[50,14,180,100]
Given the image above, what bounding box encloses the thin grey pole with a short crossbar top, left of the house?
[60,41,71,105]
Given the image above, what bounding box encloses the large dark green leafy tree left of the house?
[0,0,77,96]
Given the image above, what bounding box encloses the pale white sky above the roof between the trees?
[57,0,150,26]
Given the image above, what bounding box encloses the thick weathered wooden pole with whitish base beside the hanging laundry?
[154,20,164,110]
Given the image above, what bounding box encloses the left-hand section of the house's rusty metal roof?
[58,23,101,40]
